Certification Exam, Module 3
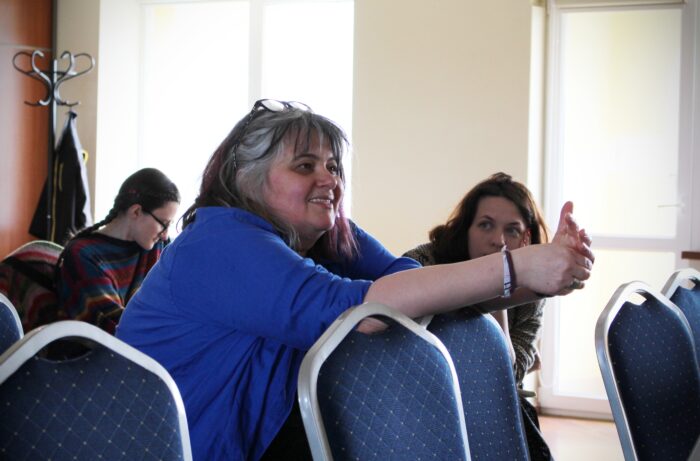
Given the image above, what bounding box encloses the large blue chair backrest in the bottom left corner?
[0,320,192,461]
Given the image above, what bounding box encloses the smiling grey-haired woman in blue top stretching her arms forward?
[117,100,593,460]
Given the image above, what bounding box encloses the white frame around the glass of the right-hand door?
[538,0,700,419]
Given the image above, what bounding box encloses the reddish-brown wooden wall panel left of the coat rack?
[0,0,53,258]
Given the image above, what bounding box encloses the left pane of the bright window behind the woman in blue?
[139,2,249,221]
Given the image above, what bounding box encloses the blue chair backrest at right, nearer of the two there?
[595,282,700,461]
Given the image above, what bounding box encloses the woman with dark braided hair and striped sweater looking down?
[56,168,180,334]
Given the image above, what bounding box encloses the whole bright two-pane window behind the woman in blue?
[97,0,354,226]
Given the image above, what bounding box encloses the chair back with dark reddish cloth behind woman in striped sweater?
[0,240,63,332]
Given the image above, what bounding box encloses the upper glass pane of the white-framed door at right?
[560,9,681,238]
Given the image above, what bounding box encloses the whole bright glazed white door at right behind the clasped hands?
[539,1,693,416]
